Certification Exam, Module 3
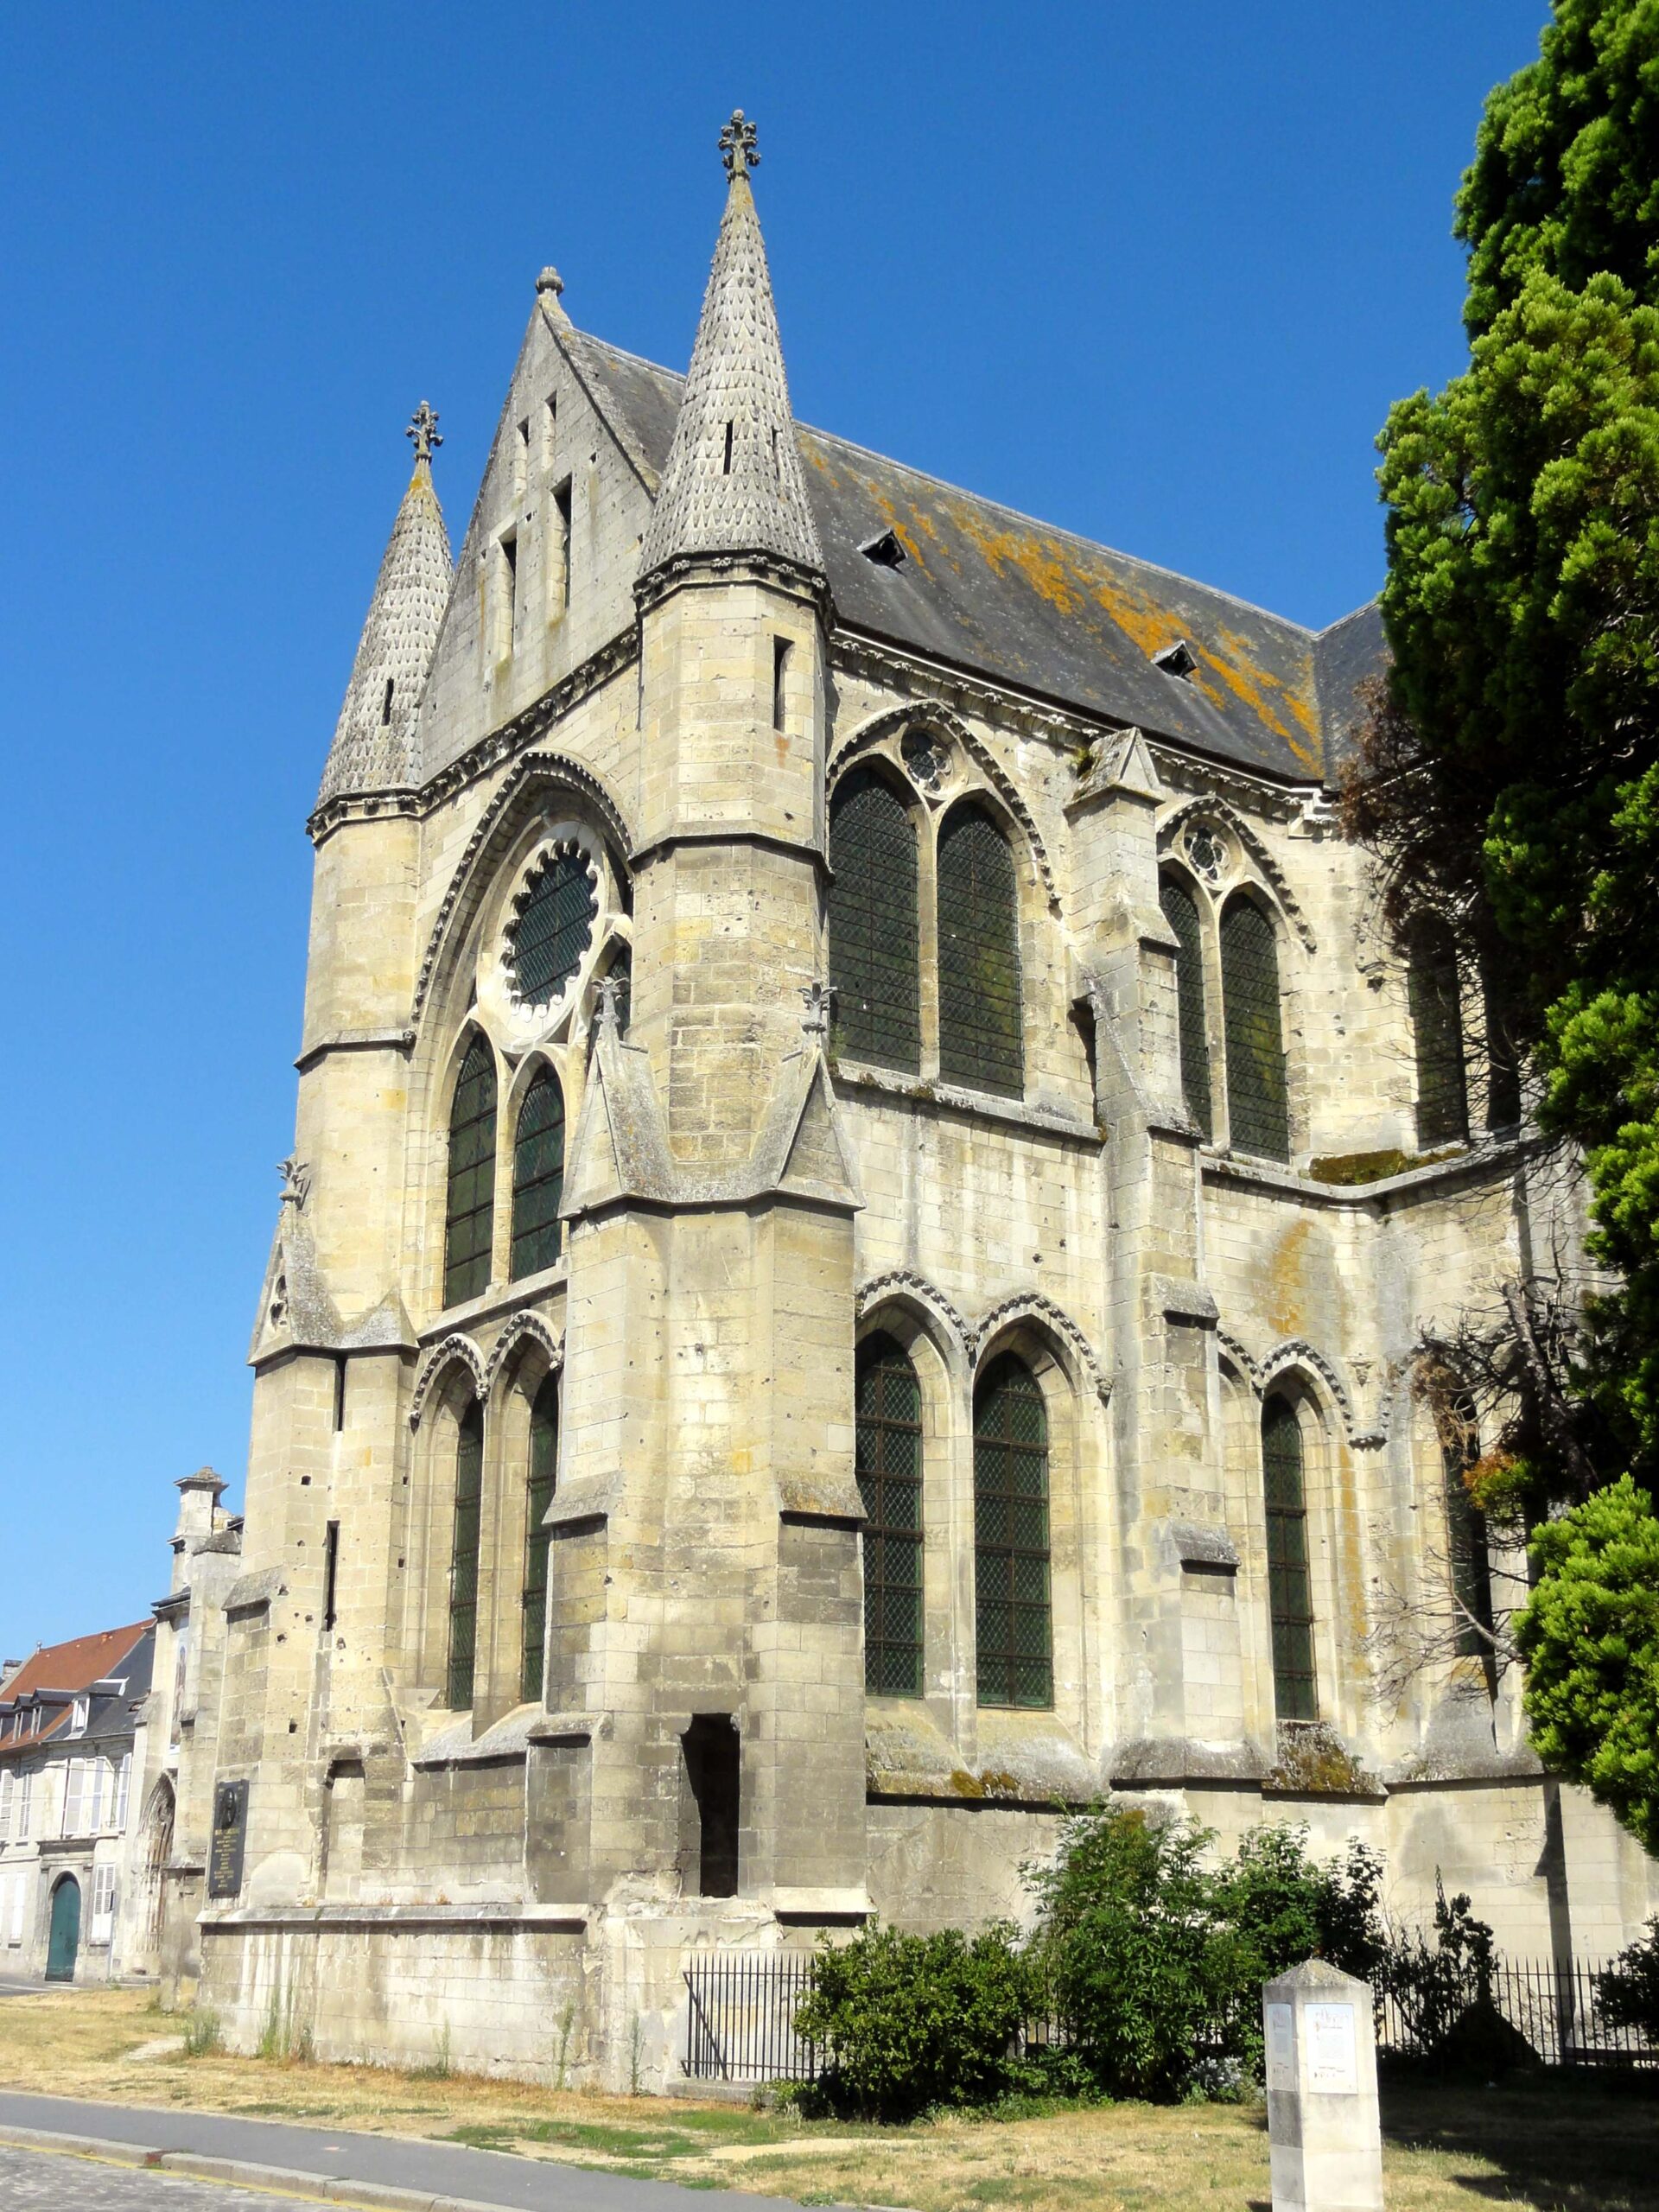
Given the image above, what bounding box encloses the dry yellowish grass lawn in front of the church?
[0,1988,1659,2212]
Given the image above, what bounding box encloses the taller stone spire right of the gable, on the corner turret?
[639,108,823,577]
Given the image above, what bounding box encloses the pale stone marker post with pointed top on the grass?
[1261,1958,1382,2212]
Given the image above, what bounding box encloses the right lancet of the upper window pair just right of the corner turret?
[938,805,1024,1099]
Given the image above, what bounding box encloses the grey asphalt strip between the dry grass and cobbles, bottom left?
[0,2090,779,2212]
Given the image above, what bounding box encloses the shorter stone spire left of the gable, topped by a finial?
[316,400,454,807]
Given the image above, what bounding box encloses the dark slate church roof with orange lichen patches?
[560,327,1382,783]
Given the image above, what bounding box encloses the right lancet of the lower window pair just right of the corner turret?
[973,1351,1055,1706]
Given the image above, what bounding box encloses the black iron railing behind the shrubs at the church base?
[683,1951,1659,2082]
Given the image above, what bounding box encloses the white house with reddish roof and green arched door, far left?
[0,1621,155,1982]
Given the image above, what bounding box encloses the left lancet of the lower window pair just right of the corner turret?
[856,1336,923,1697]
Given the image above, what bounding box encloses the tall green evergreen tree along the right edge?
[1347,0,1659,1842]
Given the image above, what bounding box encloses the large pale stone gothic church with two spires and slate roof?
[157,119,1652,2084]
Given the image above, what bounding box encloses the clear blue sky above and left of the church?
[0,0,1544,1655]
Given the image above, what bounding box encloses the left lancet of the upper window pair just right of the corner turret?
[830,767,923,1075]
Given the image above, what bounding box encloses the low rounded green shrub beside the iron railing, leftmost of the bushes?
[794,1927,1035,2119]
